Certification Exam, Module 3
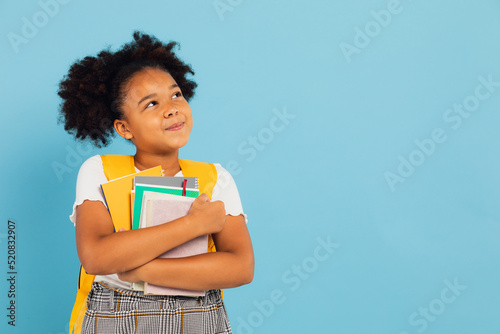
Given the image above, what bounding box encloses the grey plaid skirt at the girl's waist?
[82,282,231,334]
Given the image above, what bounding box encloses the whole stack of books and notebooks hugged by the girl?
[101,166,208,296]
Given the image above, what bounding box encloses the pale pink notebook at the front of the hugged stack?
[144,194,208,296]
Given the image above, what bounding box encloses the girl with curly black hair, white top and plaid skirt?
[59,32,254,333]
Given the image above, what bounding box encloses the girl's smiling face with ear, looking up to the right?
[115,68,193,154]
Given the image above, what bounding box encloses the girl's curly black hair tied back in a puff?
[58,31,197,147]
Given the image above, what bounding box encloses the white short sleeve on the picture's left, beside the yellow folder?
[69,155,108,224]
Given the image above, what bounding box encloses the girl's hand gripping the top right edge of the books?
[188,194,226,234]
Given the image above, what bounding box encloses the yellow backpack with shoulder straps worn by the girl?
[69,155,217,334]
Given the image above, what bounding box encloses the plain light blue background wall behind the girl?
[0,0,500,334]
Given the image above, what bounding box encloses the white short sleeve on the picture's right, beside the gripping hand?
[212,164,248,222]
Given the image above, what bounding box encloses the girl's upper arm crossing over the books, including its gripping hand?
[76,194,226,275]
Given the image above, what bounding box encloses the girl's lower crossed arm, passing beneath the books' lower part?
[118,215,254,290]
